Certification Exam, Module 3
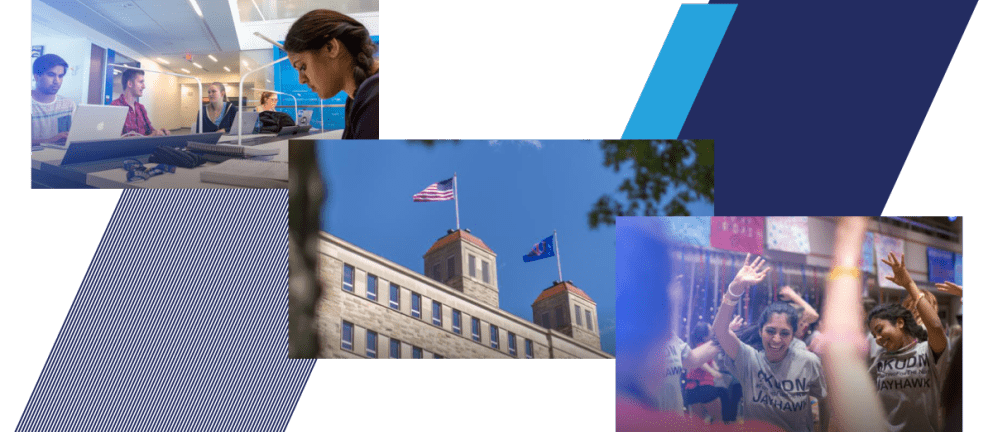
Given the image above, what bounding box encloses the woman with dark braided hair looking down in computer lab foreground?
[283,9,379,139]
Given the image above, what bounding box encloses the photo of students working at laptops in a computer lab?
[29,0,379,189]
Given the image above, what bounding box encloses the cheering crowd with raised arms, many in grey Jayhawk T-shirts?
[616,218,962,432]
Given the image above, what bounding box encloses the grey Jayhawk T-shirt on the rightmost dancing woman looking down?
[869,342,941,432]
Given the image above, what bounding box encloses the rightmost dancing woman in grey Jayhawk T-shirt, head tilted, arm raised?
[867,253,948,432]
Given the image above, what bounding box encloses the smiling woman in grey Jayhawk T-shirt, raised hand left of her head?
[714,255,827,431]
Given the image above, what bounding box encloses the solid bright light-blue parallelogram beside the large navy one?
[621,4,738,139]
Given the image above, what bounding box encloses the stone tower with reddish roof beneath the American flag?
[424,229,500,308]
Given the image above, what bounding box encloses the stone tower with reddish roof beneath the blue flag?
[531,281,600,349]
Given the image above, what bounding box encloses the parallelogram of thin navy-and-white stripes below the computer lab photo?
[17,190,315,431]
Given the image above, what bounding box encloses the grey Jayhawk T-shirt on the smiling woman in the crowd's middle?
[723,341,827,431]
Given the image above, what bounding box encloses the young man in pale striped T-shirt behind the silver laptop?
[31,54,76,145]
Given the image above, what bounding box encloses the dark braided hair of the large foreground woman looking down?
[283,9,376,87]
